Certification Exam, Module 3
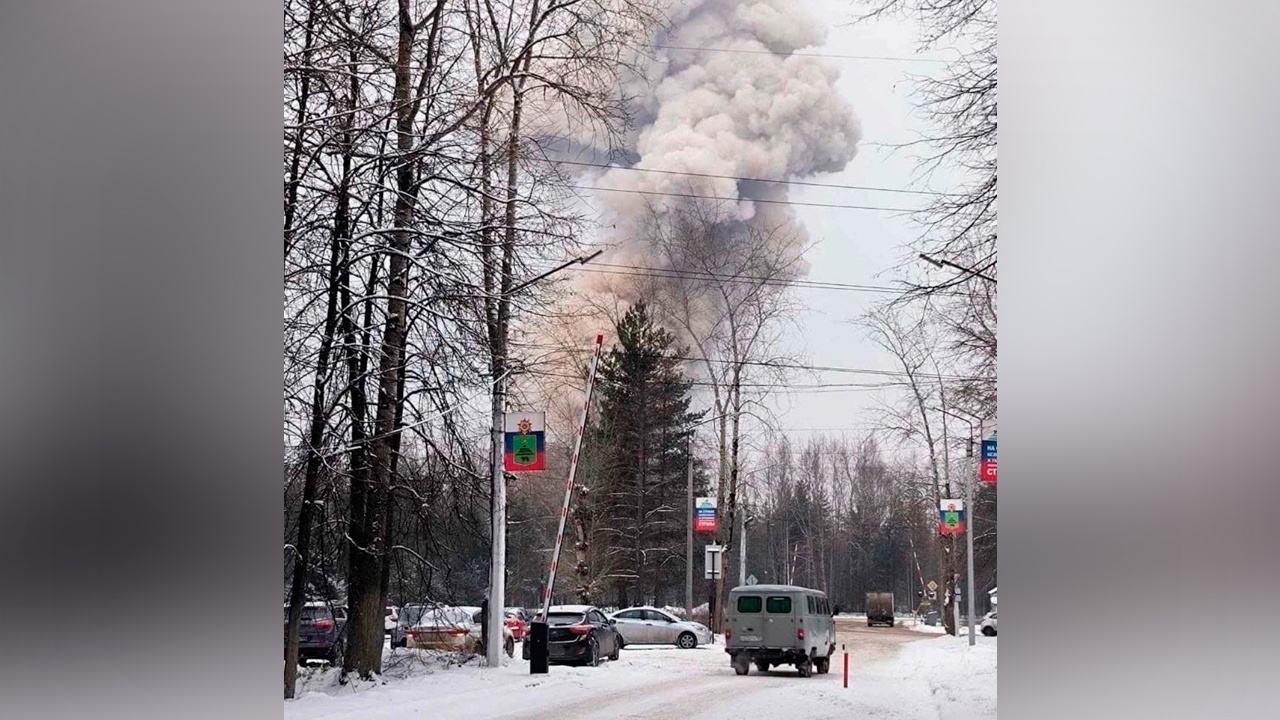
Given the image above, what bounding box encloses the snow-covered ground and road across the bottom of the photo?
[284,637,996,720]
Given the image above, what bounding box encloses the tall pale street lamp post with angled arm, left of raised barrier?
[483,250,604,667]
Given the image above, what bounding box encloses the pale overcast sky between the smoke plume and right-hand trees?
[757,0,950,448]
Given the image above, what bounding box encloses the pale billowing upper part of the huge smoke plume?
[593,0,861,264]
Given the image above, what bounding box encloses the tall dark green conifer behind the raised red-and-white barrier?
[591,301,701,607]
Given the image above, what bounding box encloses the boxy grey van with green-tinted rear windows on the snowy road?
[724,585,836,678]
